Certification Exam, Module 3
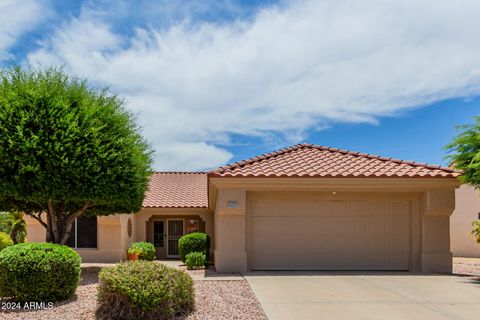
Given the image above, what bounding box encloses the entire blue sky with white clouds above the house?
[0,0,480,170]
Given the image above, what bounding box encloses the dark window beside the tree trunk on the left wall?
[66,217,97,249]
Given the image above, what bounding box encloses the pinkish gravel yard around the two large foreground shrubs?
[0,267,267,320]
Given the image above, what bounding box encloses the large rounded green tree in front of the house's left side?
[0,67,151,244]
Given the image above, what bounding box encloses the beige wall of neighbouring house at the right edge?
[450,185,480,258]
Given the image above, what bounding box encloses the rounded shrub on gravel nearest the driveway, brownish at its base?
[97,261,195,319]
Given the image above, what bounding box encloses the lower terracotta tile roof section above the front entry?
[143,172,208,208]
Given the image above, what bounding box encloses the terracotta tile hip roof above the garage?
[208,144,460,178]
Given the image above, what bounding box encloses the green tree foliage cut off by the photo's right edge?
[445,116,480,243]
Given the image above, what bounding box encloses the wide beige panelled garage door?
[250,199,410,270]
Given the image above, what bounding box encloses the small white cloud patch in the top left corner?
[0,0,47,61]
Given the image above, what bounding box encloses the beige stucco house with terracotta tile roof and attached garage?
[24,144,460,272]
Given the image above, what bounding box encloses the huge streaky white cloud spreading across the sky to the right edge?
[28,0,480,170]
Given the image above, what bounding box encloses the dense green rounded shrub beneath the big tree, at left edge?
[0,243,81,302]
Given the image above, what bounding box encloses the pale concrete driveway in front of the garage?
[245,272,480,320]
